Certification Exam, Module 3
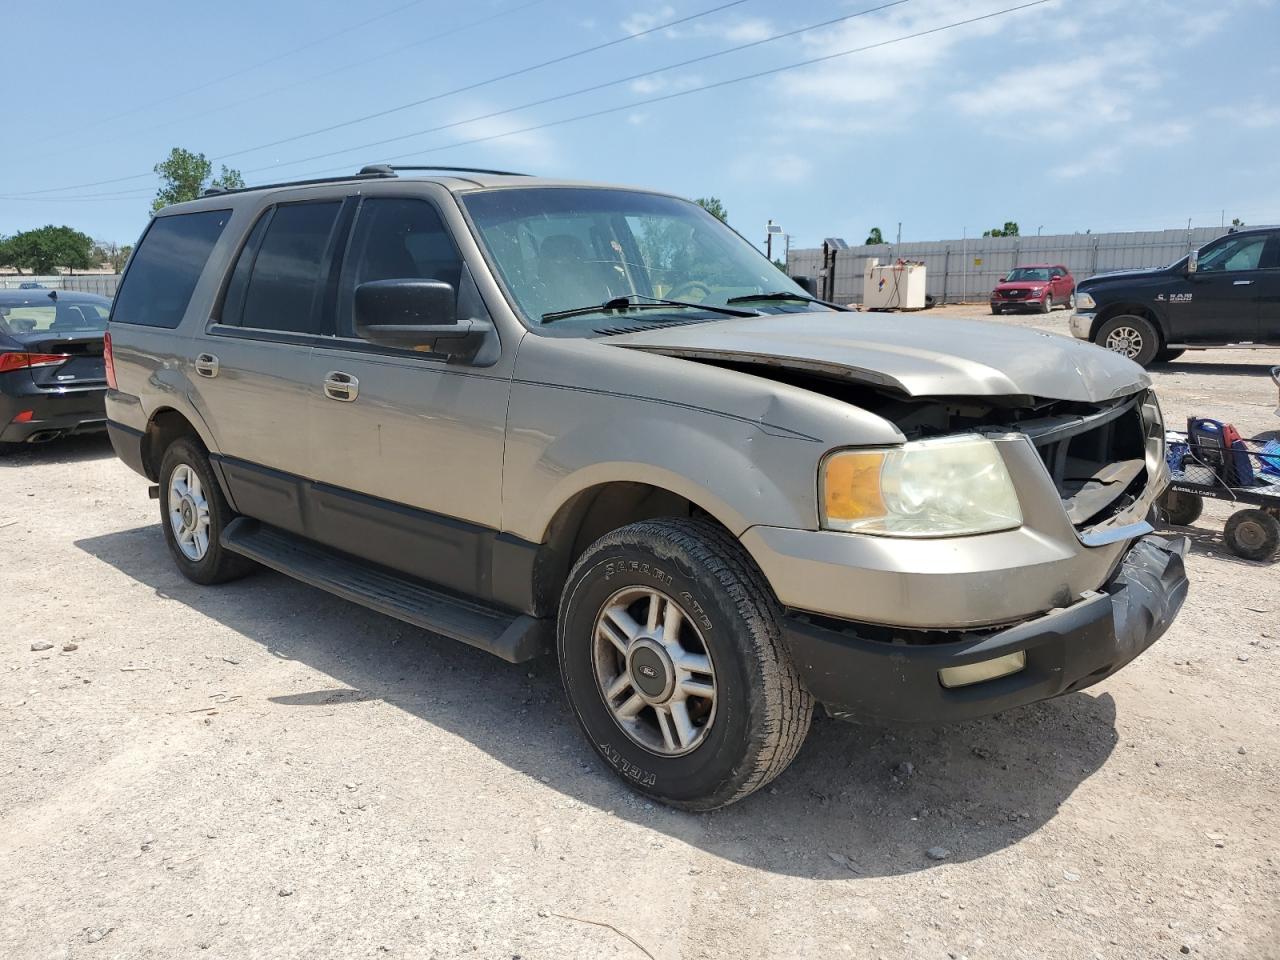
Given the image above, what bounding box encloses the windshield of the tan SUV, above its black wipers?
[462,187,823,325]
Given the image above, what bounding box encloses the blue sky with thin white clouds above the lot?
[0,0,1280,252]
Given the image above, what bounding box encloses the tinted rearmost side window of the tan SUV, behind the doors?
[111,210,232,329]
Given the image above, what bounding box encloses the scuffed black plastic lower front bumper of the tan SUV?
[783,536,1188,723]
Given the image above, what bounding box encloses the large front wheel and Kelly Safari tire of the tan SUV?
[557,520,813,810]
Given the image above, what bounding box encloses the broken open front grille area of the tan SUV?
[1020,393,1162,527]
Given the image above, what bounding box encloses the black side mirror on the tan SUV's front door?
[355,279,489,358]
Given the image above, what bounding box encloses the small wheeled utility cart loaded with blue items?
[1161,417,1280,561]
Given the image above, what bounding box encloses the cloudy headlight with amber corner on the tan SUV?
[820,434,1023,536]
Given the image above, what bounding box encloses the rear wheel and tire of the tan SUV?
[160,438,257,585]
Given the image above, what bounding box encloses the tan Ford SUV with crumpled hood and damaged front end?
[106,166,1187,810]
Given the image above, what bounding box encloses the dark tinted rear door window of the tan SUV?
[235,200,342,335]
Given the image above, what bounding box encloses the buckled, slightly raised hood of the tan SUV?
[607,312,1151,403]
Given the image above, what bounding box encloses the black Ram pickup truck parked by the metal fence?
[1071,228,1280,366]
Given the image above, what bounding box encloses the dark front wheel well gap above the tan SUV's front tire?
[535,481,723,613]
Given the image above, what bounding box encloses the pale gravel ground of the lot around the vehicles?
[0,308,1280,960]
